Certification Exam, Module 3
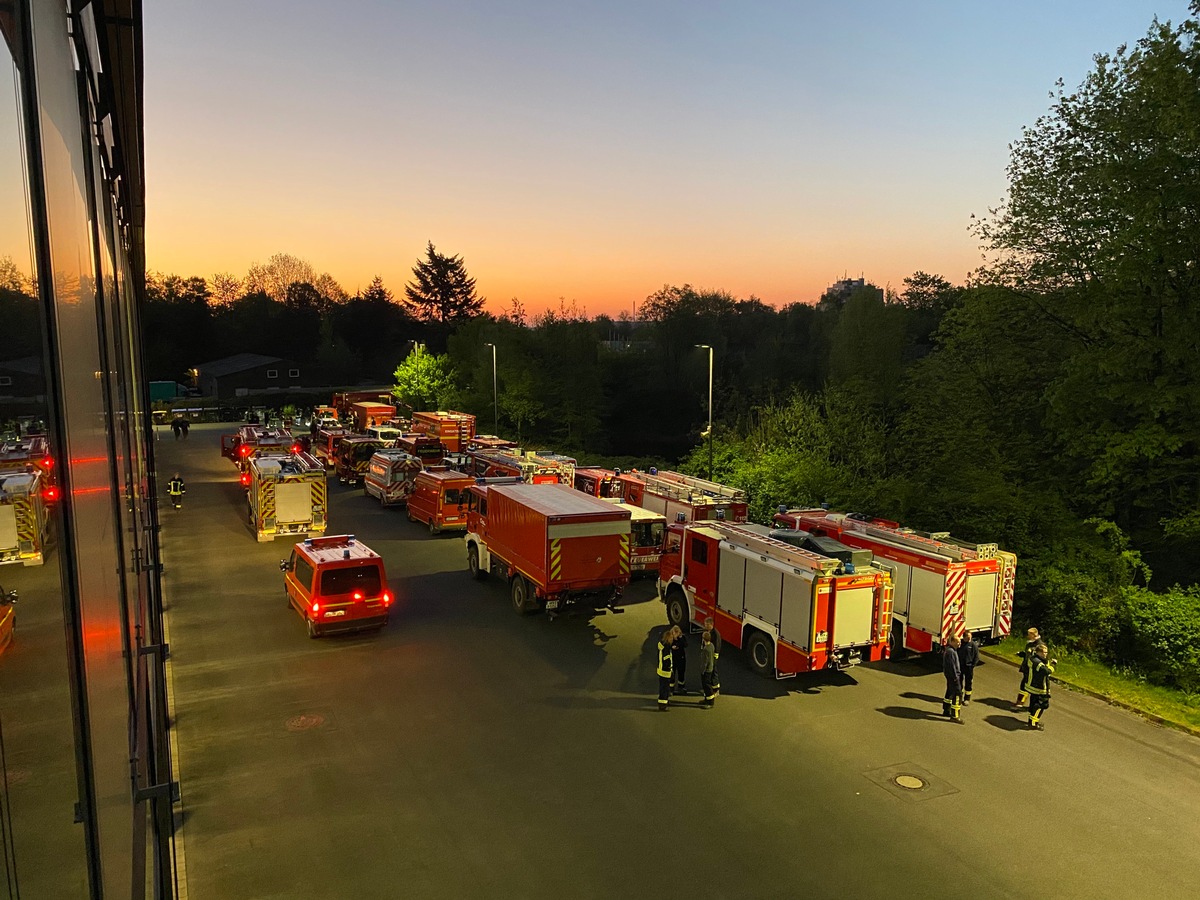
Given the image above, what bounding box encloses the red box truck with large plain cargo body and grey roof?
[466,484,630,616]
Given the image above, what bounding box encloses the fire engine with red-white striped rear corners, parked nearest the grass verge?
[775,509,1016,656]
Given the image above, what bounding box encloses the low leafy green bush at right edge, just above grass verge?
[1122,584,1200,694]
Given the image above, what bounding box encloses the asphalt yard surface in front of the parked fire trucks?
[160,427,1200,900]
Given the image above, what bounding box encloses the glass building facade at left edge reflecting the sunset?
[0,0,176,898]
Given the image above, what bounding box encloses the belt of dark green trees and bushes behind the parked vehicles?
[105,10,1200,690]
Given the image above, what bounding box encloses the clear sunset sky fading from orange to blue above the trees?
[144,0,1187,316]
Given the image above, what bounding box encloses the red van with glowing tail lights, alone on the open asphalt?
[280,534,391,637]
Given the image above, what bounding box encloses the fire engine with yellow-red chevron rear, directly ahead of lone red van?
[247,452,329,542]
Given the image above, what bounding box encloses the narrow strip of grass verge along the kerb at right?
[984,637,1200,736]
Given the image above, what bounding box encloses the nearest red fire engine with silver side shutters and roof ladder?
[659,522,892,678]
